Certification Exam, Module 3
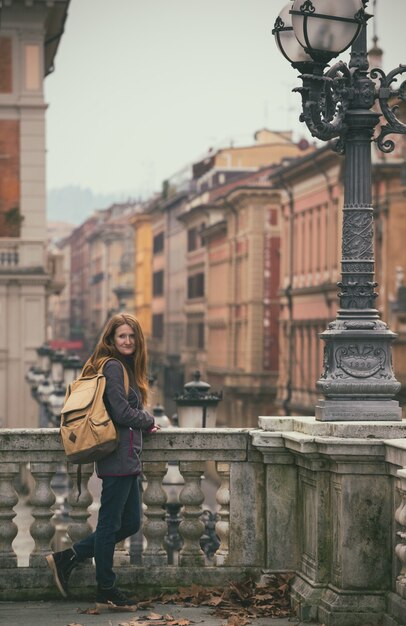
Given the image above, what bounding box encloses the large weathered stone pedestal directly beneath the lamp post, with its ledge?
[254,417,406,626]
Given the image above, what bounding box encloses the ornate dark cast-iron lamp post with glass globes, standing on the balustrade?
[272,0,406,421]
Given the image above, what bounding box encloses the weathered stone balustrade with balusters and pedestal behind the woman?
[0,417,406,626]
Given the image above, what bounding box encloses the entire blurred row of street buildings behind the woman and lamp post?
[45,132,406,426]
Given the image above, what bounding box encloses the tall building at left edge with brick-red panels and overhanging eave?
[0,0,69,427]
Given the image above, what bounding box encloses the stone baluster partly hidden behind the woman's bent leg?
[67,463,94,544]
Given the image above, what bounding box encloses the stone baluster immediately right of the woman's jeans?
[143,461,167,566]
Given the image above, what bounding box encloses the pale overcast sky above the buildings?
[45,0,406,195]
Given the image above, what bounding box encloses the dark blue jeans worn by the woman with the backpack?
[73,476,141,589]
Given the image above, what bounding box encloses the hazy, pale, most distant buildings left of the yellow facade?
[48,202,140,358]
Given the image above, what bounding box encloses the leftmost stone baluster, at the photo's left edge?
[0,463,19,569]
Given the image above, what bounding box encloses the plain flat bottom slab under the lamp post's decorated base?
[316,398,402,422]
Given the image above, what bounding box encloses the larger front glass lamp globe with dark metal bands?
[290,0,365,61]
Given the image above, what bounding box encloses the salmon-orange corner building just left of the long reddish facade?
[202,180,281,426]
